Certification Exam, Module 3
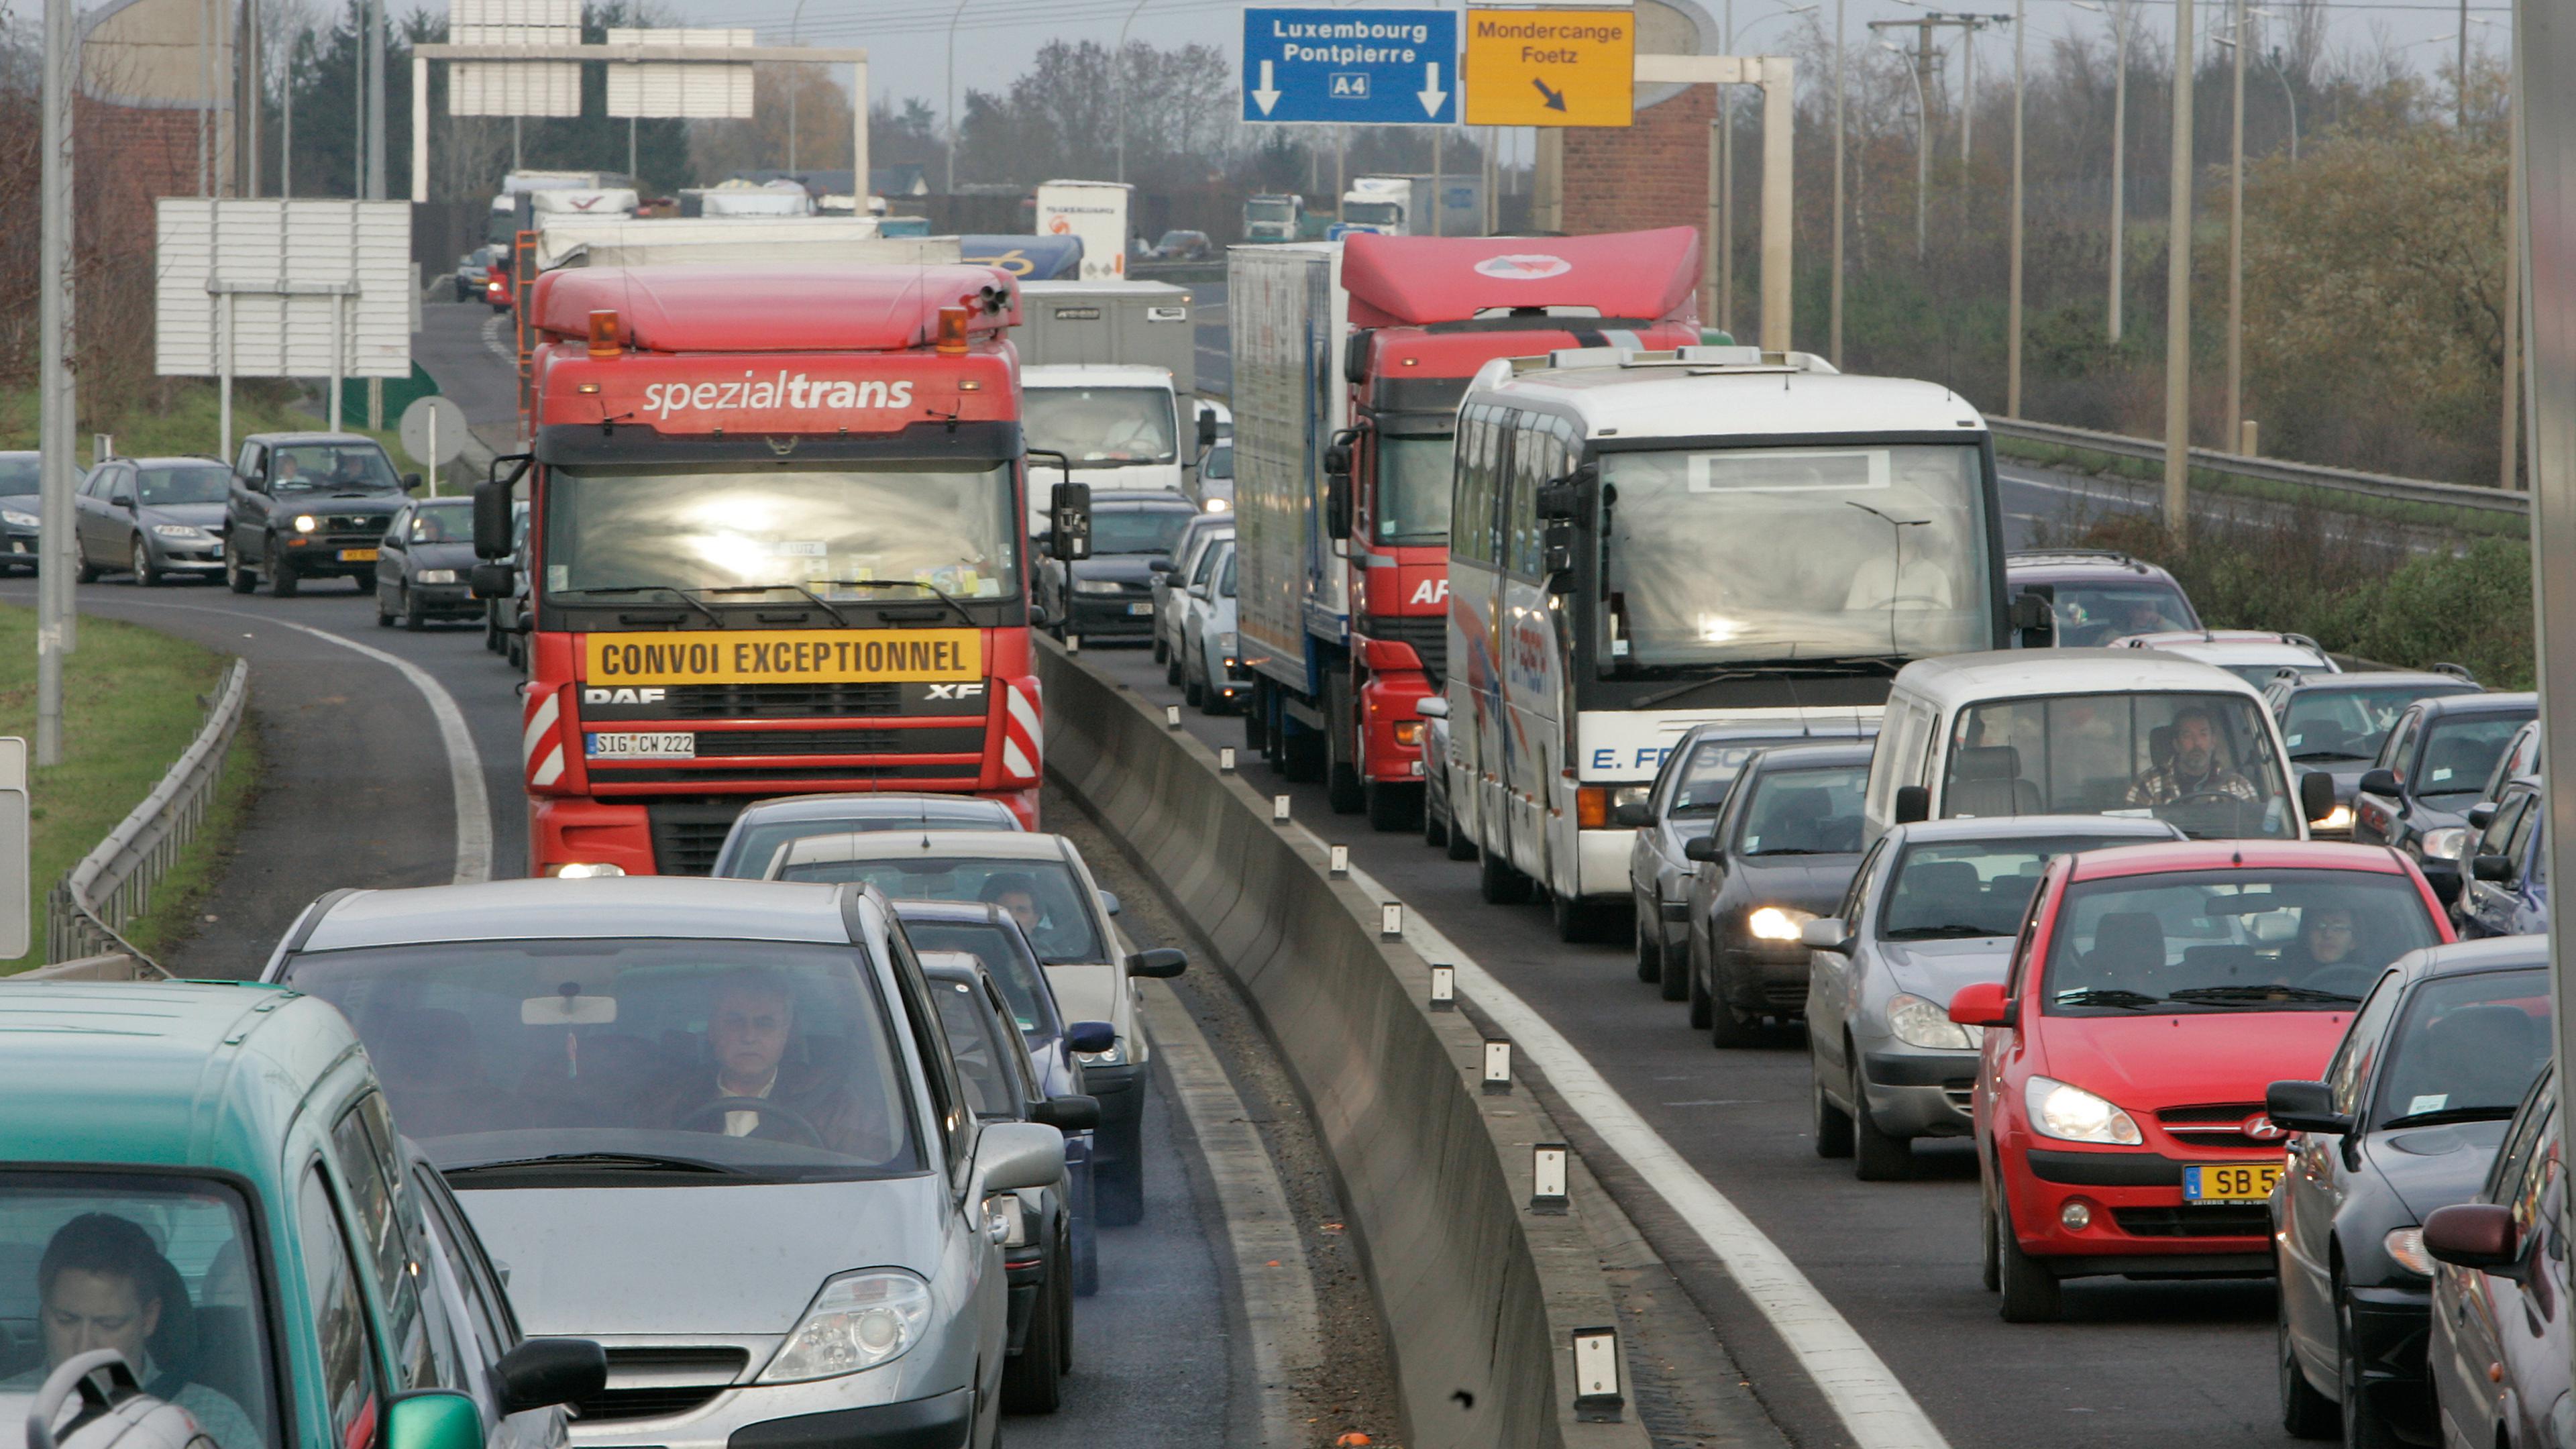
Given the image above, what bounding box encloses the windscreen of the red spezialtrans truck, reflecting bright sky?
[543,464,1020,598]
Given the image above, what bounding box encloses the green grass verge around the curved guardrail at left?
[0,606,258,975]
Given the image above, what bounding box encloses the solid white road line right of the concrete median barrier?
[1298,825,1950,1449]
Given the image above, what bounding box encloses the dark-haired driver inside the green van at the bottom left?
[0,1212,260,1449]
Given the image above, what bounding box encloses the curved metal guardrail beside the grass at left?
[44,660,250,977]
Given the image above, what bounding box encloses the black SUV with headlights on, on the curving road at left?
[224,433,420,598]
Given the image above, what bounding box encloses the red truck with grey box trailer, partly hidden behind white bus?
[1226,227,1700,830]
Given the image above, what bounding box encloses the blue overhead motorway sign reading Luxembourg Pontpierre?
[1244,10,1458,126]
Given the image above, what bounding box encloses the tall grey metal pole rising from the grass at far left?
[36,0,77,765]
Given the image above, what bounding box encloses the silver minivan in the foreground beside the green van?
[263,877,1064,1449]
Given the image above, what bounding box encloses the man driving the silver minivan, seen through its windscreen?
[657,969,894,1163]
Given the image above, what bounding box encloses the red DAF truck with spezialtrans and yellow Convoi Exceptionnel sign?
[474,266,1043,874]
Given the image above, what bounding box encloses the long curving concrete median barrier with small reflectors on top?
[1038,645,1646,1449]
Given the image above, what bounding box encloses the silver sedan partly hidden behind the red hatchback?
[1806,815,2182,1181]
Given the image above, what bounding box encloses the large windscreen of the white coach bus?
[1600,441,1994,673]
